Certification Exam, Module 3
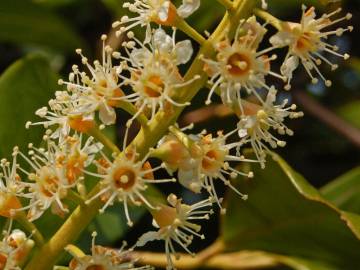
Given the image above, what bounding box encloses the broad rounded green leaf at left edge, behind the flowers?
[0,55,58,157]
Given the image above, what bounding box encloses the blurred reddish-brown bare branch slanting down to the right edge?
[293,90,360,148]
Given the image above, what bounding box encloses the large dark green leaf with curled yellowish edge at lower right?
[222,154,360,269]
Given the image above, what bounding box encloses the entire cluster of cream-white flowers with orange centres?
[0,0,353,270]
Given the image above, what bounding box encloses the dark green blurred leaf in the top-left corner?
[0,0,84,52]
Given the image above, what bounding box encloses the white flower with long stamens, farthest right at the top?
[270,6,353,89]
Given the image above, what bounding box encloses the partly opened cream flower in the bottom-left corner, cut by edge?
[0,226,34,270]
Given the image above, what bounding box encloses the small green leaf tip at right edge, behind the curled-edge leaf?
[321,167,360,214]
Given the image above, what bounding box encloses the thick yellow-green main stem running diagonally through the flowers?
[25,0,256,270]
